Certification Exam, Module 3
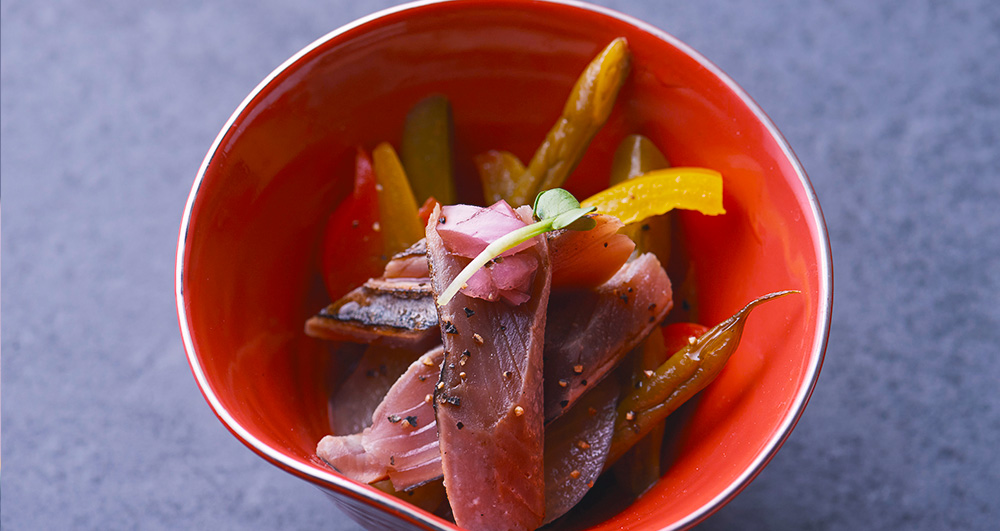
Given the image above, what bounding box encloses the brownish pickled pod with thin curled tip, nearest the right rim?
[607,291,798,465]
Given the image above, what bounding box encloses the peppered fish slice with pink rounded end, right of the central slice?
[545,253,673,422]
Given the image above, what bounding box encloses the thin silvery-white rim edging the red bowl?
[174,0,833,530]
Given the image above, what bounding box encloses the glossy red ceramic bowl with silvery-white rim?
[176,0,832,530]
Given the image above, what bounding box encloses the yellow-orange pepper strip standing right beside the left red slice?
[372,142,424,256]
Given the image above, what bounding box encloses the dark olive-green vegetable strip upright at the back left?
[399,94,456,205]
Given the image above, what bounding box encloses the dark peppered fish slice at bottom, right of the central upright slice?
[545,378,620,523]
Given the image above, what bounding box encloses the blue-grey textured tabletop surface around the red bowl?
[0,0,1000,531]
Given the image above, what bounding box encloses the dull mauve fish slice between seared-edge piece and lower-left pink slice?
[330,346,420,435]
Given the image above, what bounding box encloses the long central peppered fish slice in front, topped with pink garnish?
[427,204,550,531]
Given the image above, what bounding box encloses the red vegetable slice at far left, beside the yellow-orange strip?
[321,148,388,300]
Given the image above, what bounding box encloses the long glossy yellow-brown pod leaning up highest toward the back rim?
[509,37,632,207]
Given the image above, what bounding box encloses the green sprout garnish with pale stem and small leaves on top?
[437,188,597,306]
